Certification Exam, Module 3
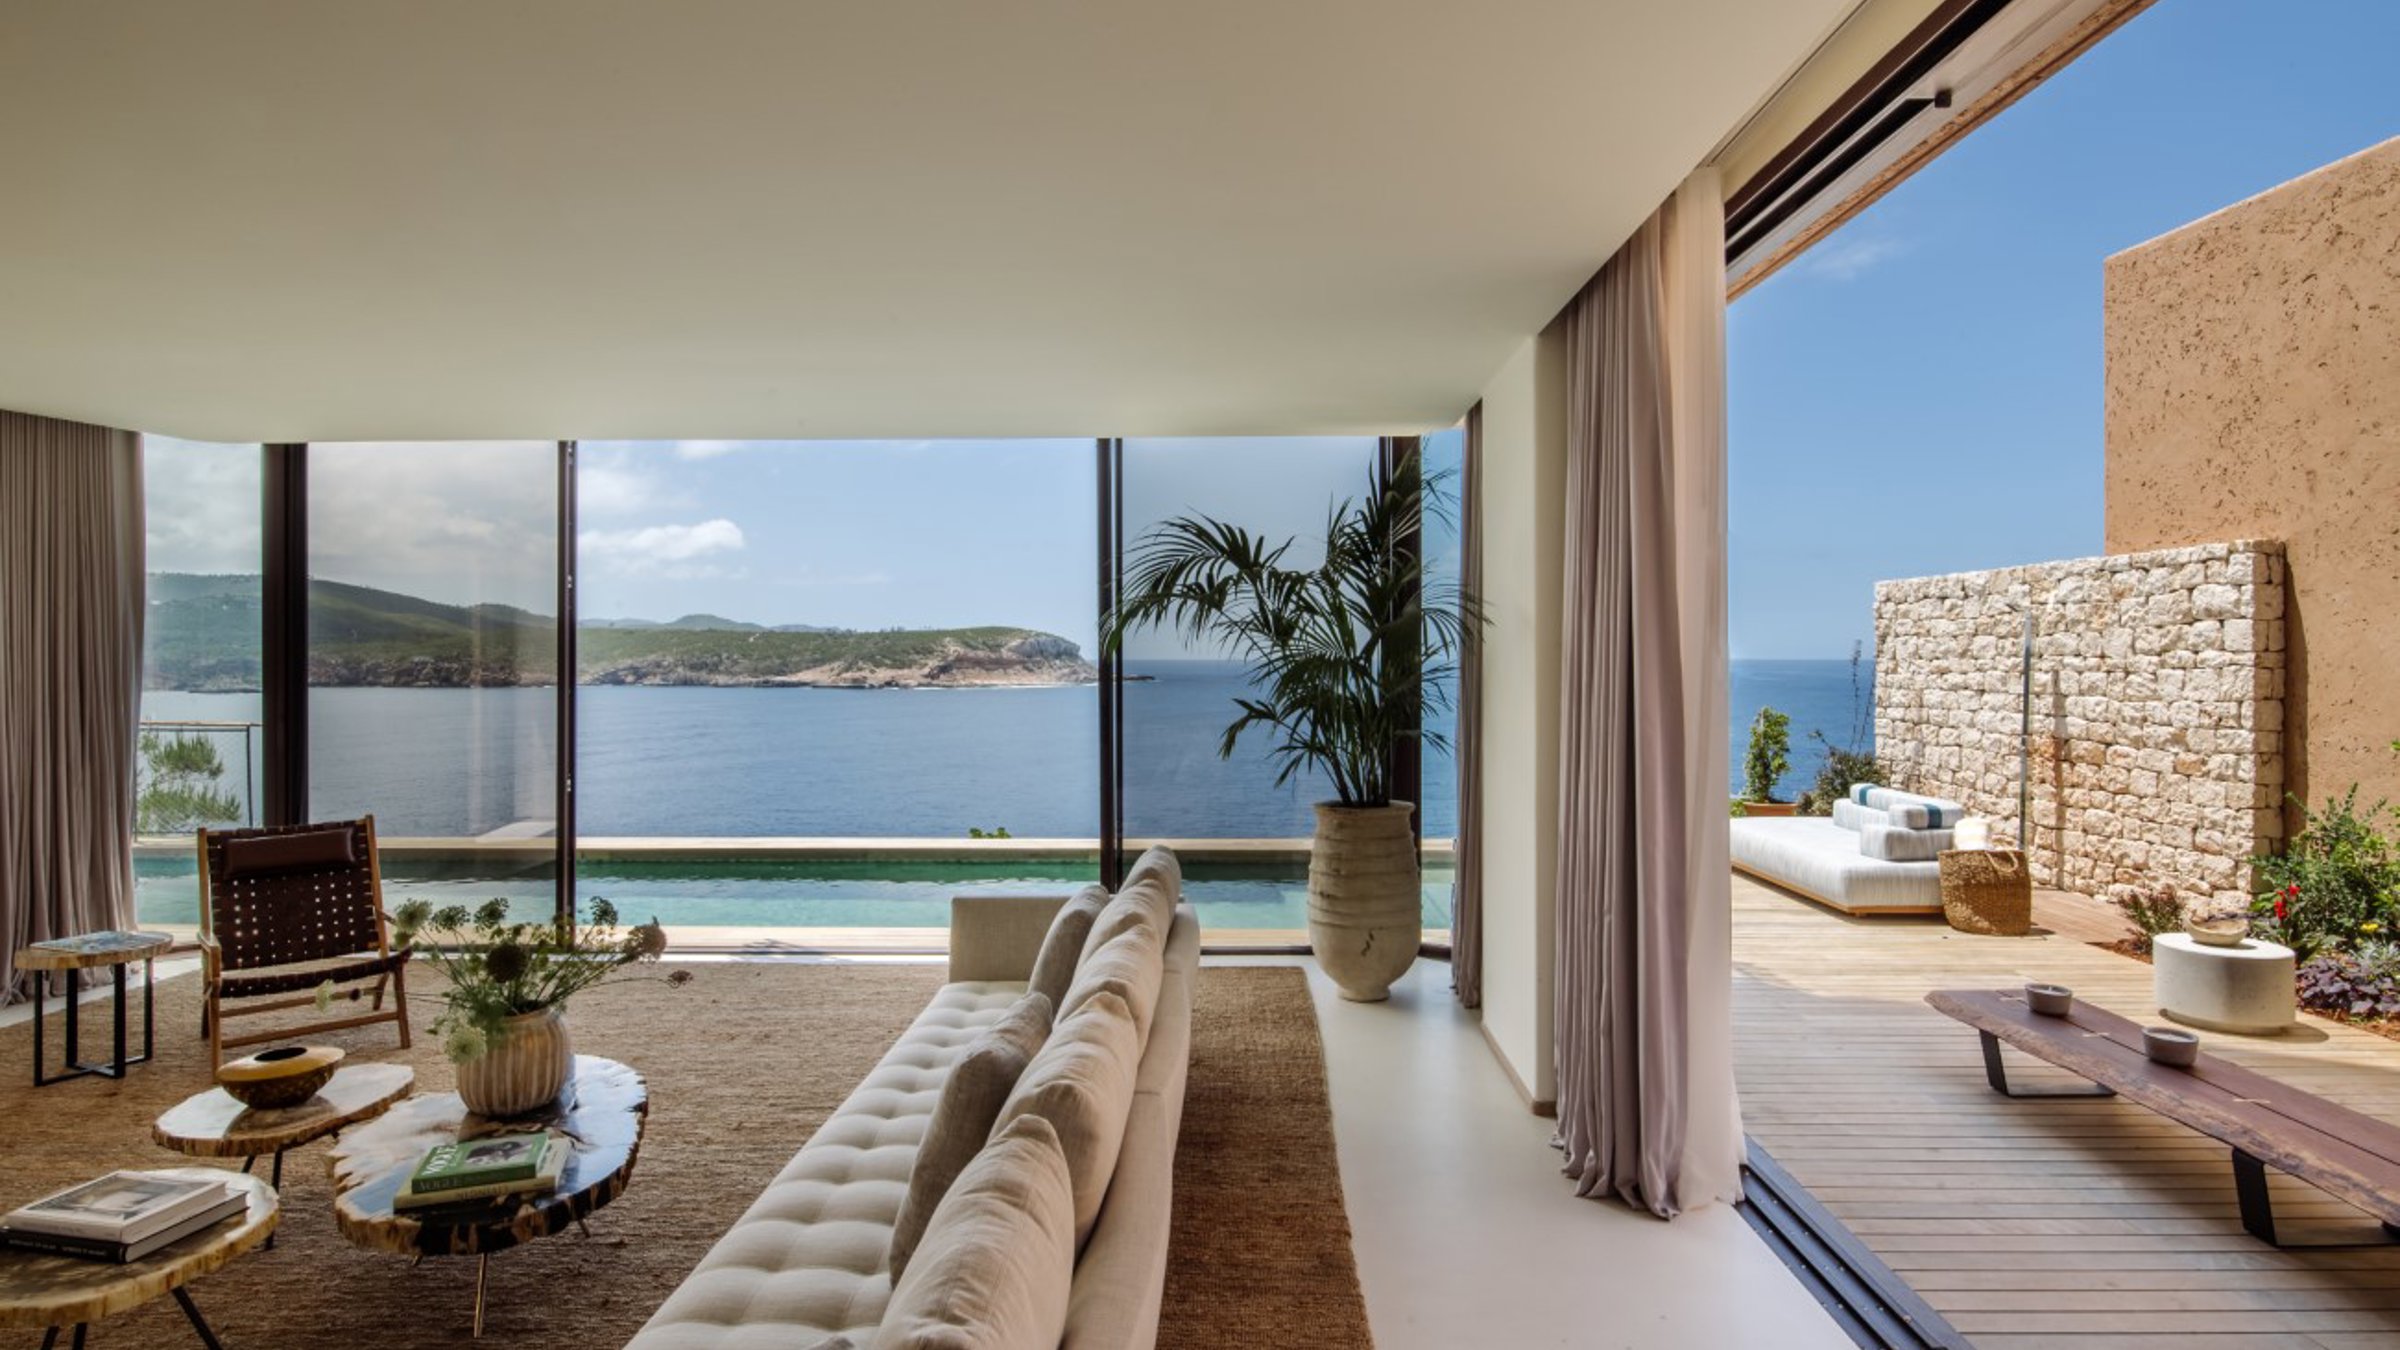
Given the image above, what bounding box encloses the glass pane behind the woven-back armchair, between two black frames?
[307,442,559,918]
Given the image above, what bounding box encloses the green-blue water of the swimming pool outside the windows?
[150,855,1452,932]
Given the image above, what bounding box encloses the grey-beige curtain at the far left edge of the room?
[0,413,144,1002]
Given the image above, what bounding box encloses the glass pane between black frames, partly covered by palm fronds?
[1123,437,1378,932]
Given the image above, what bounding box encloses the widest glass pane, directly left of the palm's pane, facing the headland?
[576,440,1099,944]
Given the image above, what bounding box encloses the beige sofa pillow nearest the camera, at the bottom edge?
[874,1117,1075,1350]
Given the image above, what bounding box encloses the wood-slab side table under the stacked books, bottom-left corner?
[0,1167,278,1350]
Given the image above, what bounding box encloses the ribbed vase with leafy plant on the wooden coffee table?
[398,898,691,1117]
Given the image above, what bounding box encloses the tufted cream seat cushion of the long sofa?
[631,980,1025,1350]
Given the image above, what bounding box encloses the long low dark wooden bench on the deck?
[1925,990,2400,1247]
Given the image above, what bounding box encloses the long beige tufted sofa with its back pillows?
[629,848,1200,1350]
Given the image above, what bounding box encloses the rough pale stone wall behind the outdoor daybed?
[1874,540,2285,901]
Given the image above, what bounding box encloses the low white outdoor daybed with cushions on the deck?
[1733,783,1966,915]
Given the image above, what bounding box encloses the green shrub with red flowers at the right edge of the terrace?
[2251,785,2400,961]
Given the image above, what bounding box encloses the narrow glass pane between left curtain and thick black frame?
[134,435,264,927]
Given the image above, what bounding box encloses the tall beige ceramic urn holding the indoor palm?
[1308,802,1426,1004]
